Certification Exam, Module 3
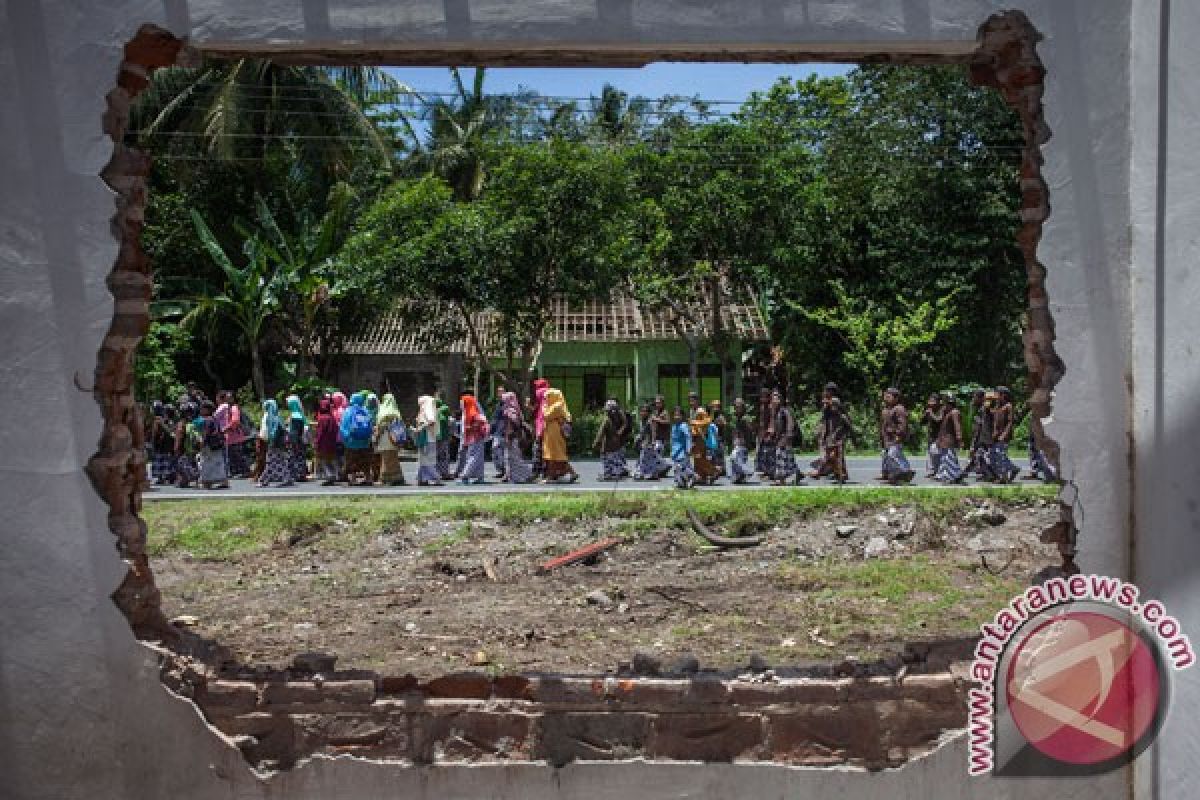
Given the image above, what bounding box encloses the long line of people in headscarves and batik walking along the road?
[148,379,1055,488]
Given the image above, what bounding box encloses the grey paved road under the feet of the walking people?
[143,456,1037,500]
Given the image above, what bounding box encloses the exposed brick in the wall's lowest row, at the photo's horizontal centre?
[534,711,654,766]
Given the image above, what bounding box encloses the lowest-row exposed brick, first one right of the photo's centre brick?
[647,711,763,762]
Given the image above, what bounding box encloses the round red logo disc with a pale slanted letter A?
[1004,610,1168,768]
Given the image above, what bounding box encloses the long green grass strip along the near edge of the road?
[143,486,1056,559]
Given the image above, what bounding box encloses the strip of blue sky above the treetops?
[388,62,851,103]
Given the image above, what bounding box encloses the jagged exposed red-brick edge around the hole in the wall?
[89,13,1076,766]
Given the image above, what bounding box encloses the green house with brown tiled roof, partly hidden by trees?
[337,296,767,410]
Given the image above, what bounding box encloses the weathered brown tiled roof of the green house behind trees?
[342,295,767,355]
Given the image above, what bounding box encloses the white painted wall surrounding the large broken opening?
[0,0,1200,800]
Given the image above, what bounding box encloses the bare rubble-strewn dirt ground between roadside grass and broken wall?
[154,498,1058,678]
